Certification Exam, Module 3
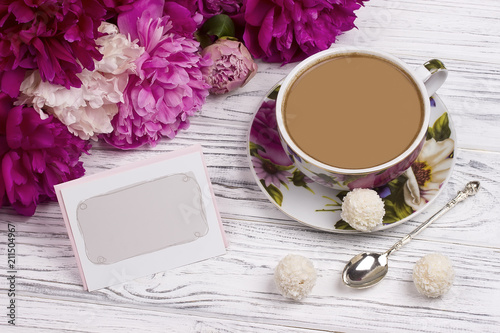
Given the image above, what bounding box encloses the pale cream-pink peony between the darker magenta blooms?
[17,22,144,140]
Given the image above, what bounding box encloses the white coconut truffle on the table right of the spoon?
[413,253,455,297]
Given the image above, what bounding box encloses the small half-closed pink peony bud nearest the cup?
[201,39,257,95]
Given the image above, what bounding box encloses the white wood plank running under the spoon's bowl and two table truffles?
[0,217,500,332]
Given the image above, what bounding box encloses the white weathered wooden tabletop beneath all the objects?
[0,0,500,332]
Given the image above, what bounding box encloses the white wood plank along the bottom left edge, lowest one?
[0,296,316,333]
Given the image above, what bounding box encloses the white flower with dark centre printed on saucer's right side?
[403,139,454,210]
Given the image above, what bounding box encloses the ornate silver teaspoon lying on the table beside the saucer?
[342,181,479,289]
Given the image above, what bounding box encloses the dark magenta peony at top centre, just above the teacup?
[243,0,366,63]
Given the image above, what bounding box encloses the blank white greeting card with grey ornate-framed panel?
[55,146,226,291]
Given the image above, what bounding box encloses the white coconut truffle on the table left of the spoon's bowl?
[274,254,317,301]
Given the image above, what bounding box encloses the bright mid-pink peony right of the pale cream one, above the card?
[104,12,210,149]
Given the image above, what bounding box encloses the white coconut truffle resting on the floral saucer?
[340,188,385,231]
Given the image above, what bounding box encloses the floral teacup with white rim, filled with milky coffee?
[276,48,448,190]
